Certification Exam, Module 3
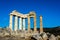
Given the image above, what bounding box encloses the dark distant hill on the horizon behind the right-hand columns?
[31,26,60,36]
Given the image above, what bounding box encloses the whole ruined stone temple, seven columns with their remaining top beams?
[9,10,43,32]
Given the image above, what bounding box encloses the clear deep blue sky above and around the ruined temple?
[0,0,60,28]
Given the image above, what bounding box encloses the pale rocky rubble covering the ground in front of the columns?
[0,30,60,40]
